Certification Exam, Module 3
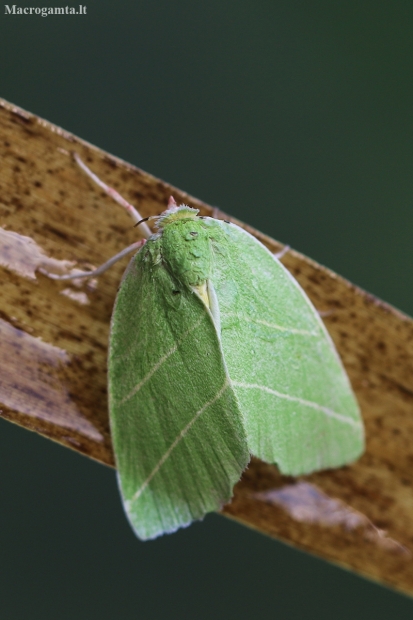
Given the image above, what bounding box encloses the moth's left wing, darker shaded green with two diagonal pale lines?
[109,242,249,539]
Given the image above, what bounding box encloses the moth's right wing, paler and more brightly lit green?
[211,222,364,475]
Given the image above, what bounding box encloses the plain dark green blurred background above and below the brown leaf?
[0,0,413,620]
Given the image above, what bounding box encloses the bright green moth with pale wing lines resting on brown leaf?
[46,159,364,540]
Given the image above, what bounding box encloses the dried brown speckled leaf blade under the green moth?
[0,101,413,594]
